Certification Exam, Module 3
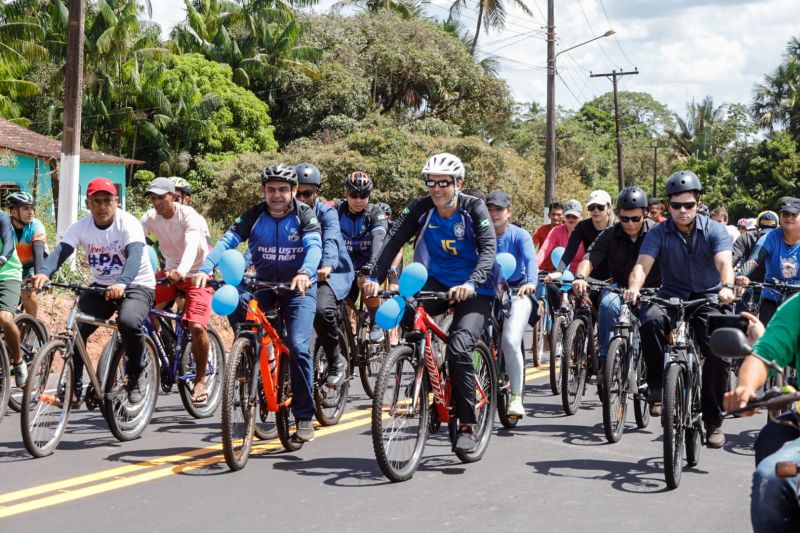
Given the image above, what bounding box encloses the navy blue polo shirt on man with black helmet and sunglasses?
[639,215,733,300]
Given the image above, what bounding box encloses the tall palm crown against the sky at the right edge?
[750,37,800,141]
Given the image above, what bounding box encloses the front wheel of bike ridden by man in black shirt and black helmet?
[603,337,629,443]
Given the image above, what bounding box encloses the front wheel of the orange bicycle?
[222,337,258,470]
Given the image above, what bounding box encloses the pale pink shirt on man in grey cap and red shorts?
[141,203,208,276]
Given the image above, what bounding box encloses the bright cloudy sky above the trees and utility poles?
[153,0,800,112]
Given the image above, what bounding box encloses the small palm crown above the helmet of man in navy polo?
[667,96,725,159]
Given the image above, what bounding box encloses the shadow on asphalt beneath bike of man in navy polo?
[526,457,708,494]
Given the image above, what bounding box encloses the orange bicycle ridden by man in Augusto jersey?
[222,279,303,470]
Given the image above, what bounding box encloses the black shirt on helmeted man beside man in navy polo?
[588,218,661,287]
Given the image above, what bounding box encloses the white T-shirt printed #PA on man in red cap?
[61,209,156,289]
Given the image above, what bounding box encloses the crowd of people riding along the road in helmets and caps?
[0,153,800,531]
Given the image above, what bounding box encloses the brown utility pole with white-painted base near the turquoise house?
[56,0,85,240]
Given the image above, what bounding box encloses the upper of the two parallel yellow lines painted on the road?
[0,409,371,504]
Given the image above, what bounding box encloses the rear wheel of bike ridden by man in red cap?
[103,337,160,442]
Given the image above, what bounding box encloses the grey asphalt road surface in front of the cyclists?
[0,352,763,533]
